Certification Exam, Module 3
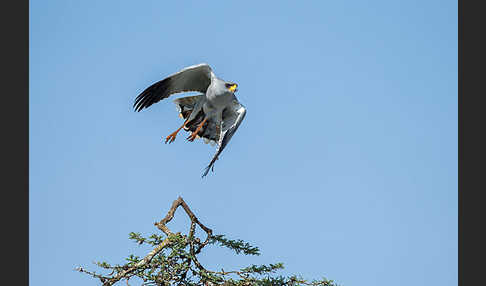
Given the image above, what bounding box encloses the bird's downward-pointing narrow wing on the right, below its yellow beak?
[202,100,246,177]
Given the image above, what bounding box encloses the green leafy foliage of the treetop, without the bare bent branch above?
[77,232,336,286]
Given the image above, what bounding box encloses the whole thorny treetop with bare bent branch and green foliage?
[76,197,336,286]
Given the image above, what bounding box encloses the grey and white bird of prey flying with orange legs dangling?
[133,63,246,177]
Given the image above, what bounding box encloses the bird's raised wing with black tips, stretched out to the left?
[133,64,212,111]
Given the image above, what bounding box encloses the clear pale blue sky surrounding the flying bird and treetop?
[29,0,457,286]
